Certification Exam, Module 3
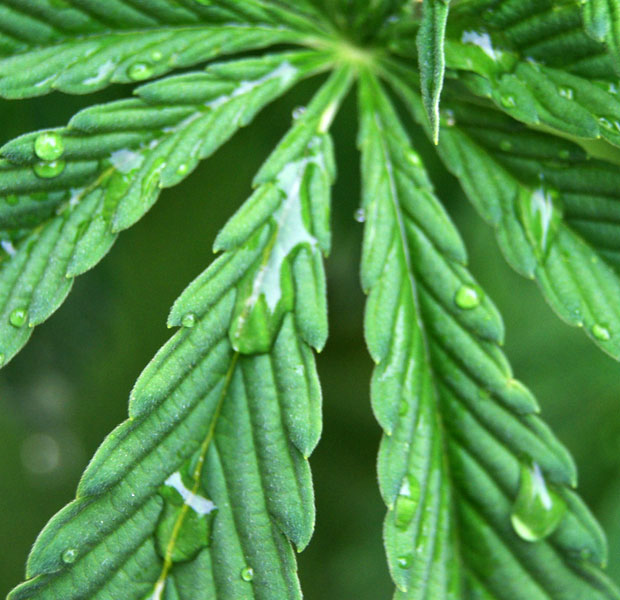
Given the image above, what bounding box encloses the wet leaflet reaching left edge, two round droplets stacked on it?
[0,51,329,364]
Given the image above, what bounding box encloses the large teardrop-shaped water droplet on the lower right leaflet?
[510,463,566,542]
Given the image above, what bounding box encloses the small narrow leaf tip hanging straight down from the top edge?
[417,0,450,144]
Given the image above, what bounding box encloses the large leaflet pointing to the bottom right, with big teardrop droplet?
[359,73,620,600]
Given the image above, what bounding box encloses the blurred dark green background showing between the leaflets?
[0,72,620,600]
